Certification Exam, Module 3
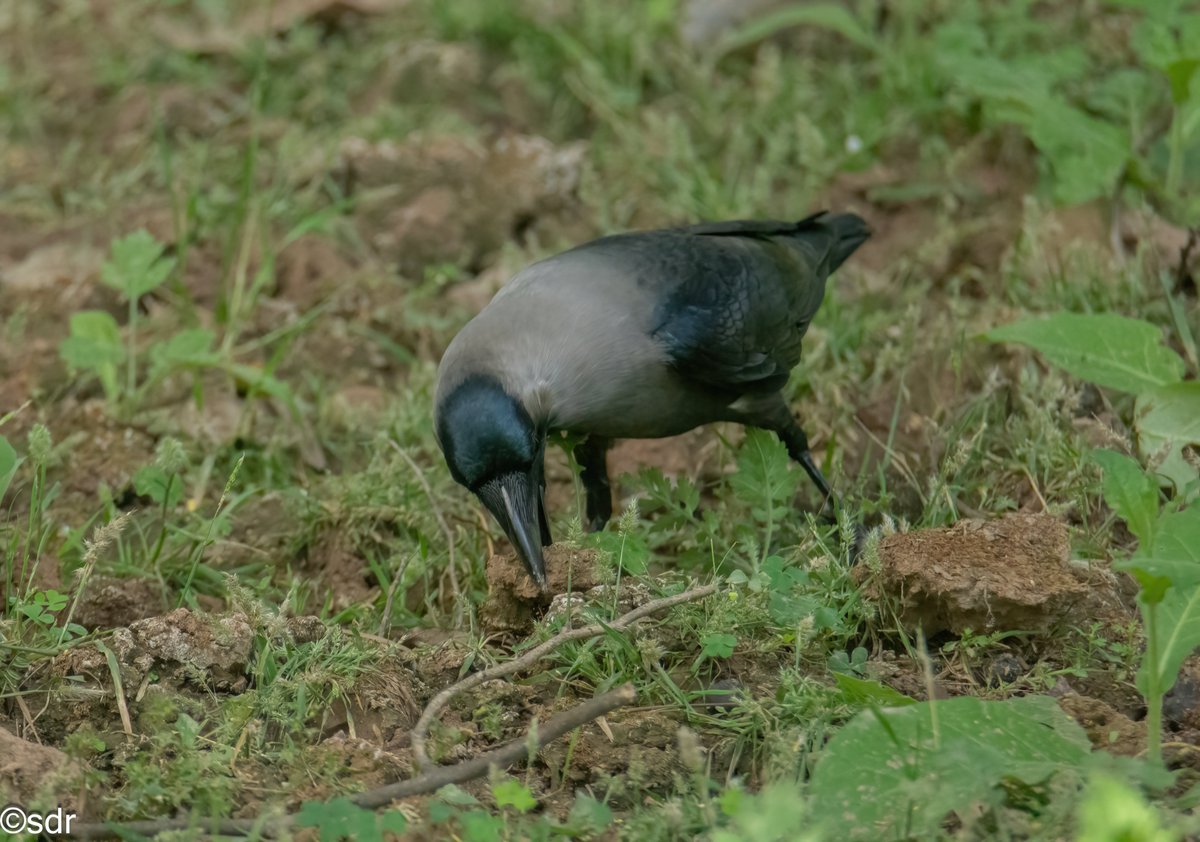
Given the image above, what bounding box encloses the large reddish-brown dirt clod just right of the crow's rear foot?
[856,513,1087,636]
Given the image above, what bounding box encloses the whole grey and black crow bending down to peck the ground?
[434,213,870,583]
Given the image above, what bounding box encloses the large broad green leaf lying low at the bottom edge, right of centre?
[810,696,1091,840]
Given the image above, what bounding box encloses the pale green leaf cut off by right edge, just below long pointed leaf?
[1134,380,1200,491]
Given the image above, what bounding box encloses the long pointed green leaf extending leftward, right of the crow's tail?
[986,313,1183,395]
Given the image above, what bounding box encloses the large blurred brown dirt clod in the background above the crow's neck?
[340,134,587,277]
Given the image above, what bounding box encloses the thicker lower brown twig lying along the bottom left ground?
[72,684,636,840]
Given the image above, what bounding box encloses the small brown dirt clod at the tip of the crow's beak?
[480,543,600,631]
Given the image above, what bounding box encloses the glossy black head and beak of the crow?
[437,375,550,588]
